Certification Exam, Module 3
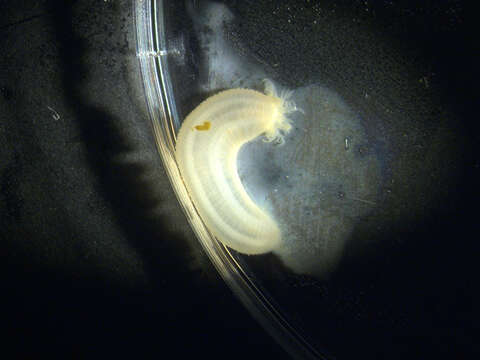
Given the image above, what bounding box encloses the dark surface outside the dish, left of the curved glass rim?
[0,0,285,359]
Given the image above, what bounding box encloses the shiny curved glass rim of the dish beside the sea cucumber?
[132,0,325,359]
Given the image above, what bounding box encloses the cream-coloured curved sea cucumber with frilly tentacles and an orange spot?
[175,82,294,254]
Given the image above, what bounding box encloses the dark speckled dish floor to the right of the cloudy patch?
[219,0,480,360]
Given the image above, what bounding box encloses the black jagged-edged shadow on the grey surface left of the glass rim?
[0,1,284,358]
